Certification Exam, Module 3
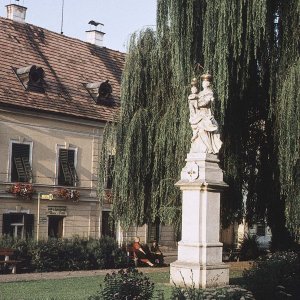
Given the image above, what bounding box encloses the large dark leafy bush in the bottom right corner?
[243,252,300,300]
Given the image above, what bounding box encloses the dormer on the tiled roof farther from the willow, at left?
[14,65,45,93]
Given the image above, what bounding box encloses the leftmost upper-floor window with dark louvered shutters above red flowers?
[10,143,32,182]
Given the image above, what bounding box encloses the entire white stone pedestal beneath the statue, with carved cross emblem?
[170,153,229,288]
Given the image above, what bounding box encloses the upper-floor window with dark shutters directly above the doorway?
[58,149,78,186]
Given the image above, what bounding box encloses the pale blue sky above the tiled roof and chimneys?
[0,0,157,52]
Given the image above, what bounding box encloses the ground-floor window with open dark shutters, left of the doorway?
[2,213,34,238]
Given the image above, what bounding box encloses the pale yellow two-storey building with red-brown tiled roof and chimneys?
[0,4,125,239]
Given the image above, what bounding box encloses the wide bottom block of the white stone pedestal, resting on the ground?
[170,260,229,288]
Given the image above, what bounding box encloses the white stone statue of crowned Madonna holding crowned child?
[188,74,222,154]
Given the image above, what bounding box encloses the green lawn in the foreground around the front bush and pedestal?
[0,271,241,300]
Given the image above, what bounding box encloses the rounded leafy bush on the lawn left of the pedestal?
[88,268,154,300]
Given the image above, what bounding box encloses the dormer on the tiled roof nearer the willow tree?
[84,80,116,106]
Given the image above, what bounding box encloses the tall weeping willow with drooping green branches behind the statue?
[100,0,300,247]
